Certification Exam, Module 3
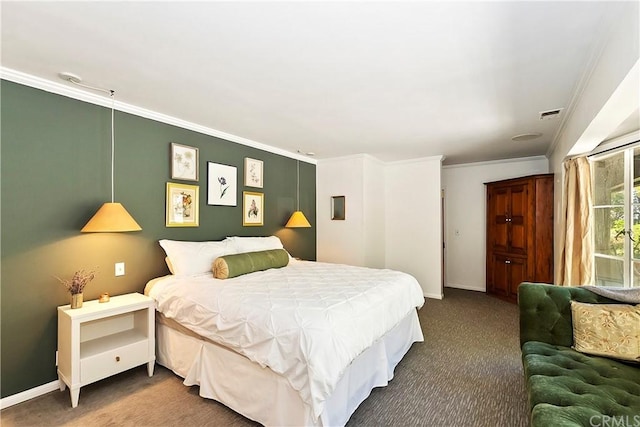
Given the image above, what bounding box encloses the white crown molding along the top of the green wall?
[0,67,317,165]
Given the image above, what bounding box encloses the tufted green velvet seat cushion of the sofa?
[522,341,640,426]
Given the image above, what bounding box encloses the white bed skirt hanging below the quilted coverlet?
[156,310,424,426]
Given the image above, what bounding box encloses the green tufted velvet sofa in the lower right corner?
[518,283,640,427]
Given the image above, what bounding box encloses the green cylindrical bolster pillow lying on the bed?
[213,249,289,279]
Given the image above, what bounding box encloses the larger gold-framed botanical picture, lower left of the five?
[165,182,200,227]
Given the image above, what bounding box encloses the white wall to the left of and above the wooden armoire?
[442,157,549,292]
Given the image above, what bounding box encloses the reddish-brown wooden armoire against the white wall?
[485,174,553,302]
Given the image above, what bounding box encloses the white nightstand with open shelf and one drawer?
[58,293,156,408]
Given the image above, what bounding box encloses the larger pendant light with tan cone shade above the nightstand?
[60,73,142,233]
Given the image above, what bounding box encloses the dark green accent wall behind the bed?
[0,80,316,398]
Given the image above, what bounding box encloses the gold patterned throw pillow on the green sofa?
[571,301,640,362]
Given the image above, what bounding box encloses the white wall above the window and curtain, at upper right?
[548,2,640,280]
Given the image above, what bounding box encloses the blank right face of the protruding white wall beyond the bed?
[385,156,443,299]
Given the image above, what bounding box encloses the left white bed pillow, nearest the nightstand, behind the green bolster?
[159,239,236,276]
